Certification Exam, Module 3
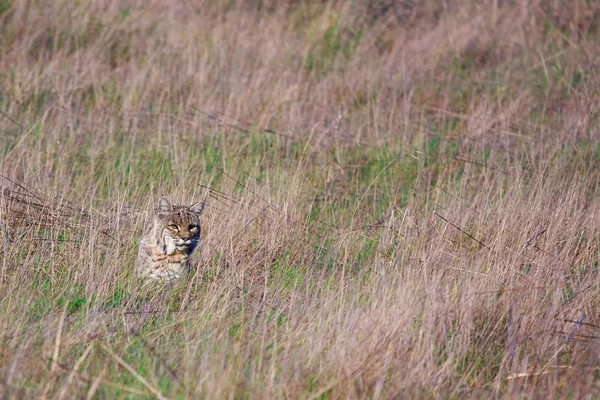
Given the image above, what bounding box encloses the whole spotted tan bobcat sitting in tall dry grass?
[137,196,204,282]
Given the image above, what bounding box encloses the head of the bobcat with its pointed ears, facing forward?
[155,197,204,256]
